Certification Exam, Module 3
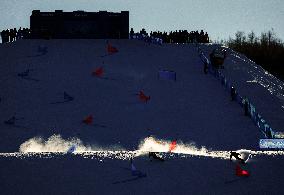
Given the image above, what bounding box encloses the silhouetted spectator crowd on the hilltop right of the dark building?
[130,28,209,43]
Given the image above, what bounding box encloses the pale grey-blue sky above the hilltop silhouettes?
[0,0,284,40]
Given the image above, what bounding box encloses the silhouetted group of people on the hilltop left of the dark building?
[1,27,30,43]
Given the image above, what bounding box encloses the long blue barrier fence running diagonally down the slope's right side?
[198,47,276,138]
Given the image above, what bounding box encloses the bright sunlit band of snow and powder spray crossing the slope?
[0,135,284,160]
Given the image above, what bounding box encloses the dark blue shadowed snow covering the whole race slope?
[0,40,284,194]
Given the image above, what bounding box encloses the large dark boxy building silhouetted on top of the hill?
[30,10,129,39]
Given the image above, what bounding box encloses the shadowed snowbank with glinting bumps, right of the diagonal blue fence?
[201,45,284,132]
